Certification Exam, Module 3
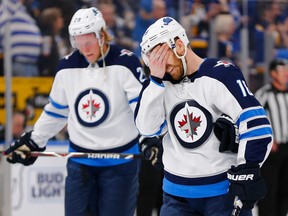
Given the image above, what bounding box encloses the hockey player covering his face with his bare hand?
[135,17,272,216]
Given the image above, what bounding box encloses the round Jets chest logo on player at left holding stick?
[75,89,109,127]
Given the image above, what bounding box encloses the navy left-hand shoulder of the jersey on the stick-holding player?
[57,50,89,72]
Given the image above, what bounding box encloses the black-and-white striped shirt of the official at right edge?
[255,83,288,144]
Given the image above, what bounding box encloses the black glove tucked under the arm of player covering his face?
[213,115,239,153]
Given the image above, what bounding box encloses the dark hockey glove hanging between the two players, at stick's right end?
[140,137,163,170]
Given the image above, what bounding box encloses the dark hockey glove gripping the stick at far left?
[4,131,46,166]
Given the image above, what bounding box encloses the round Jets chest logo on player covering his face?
[170,100,212,148]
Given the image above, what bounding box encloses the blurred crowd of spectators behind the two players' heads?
[0,0,288,90]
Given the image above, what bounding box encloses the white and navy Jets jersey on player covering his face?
[135,59,272,198]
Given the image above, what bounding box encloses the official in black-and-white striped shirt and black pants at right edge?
[255,59,288,216]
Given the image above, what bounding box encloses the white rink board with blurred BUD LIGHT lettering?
[11,141,68,216]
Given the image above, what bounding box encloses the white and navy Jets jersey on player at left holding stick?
[32,45,145,165]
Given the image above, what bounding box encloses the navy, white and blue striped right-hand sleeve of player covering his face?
[207,62,273,165]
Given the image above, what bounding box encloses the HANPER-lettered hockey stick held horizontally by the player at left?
[1,151,142,160]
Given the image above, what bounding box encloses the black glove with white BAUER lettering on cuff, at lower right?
[227,164,267,210]
